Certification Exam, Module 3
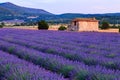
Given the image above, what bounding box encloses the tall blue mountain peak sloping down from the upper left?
[0,2,53,15]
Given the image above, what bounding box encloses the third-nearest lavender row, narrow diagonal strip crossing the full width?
[0,33,120,69]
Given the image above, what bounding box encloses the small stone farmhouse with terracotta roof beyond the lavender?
[68,18,99,31]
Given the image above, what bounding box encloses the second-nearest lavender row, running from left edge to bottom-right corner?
[0,28,120,80]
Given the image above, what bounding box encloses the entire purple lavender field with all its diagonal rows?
[0,29,120,80]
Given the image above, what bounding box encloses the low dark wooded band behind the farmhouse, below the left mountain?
[0,13,120,25]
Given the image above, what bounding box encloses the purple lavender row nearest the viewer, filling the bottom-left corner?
[0,51,65,80]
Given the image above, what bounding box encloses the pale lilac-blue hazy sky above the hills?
[0,0,120,14]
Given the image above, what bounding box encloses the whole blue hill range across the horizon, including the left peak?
[0,2,120,24]
